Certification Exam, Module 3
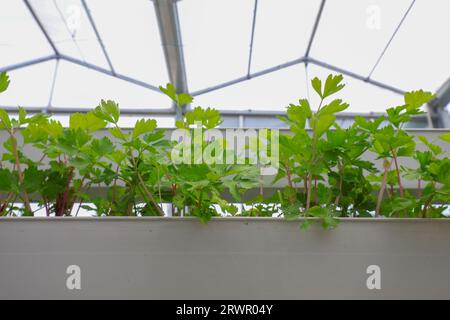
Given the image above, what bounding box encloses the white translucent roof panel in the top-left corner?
[0,0,53,67]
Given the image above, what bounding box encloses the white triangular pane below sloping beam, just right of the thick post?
[193,64,306,110]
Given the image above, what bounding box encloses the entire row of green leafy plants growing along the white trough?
[0,73,450,228]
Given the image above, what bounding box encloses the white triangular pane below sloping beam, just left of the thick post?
[52,61,171,108]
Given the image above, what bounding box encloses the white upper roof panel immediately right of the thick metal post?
[177,0,254,91]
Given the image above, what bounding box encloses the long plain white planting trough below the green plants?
[0,217,450,299]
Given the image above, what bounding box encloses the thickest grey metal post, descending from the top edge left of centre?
[153,0,189,118]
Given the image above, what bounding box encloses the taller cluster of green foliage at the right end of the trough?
[277,75,450,228]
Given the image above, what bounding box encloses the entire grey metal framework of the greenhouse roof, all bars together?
[0,0,444,128]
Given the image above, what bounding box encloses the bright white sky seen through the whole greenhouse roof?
[0,0,450,112]
